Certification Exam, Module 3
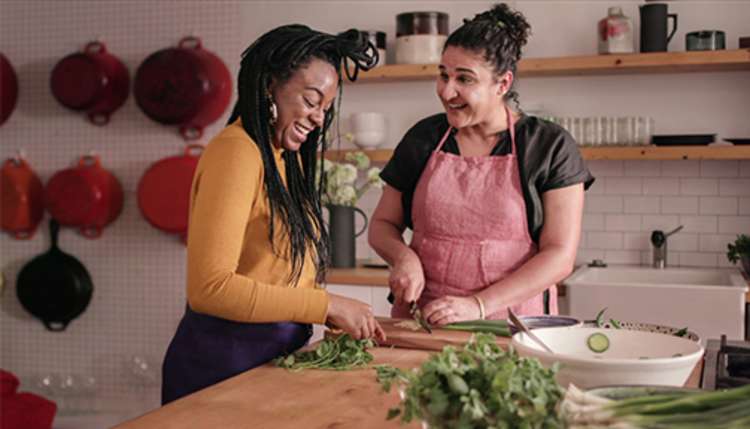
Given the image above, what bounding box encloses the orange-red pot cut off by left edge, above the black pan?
[0,157,44,240]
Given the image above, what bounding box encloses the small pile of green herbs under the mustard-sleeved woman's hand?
[273,334,375,371]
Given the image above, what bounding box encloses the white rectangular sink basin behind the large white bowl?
[563,265,748,343]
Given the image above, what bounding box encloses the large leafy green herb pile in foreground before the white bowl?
[375,333,564,429]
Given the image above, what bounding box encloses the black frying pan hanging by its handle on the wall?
[16,219,94,331]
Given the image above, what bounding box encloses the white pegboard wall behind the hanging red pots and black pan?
[0,0,244,406]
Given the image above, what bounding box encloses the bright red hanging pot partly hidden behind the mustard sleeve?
[138,144,203,240]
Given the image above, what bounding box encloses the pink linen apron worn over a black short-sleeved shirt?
[391,107,557,319]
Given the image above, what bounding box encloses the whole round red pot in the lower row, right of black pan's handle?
[44,156,123,238]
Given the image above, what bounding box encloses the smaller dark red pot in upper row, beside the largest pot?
[50,42,130,125]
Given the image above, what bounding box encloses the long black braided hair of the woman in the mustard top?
[228,24,378,284]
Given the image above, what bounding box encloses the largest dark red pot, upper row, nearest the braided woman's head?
[134,37,232,140]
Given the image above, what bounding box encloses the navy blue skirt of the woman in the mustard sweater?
[161,306,312,405]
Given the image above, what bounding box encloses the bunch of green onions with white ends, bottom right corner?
[561,384,750,429]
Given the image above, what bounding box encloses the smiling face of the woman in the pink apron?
[437,46,513,129]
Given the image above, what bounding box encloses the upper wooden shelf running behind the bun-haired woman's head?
[357,49,750,82]
